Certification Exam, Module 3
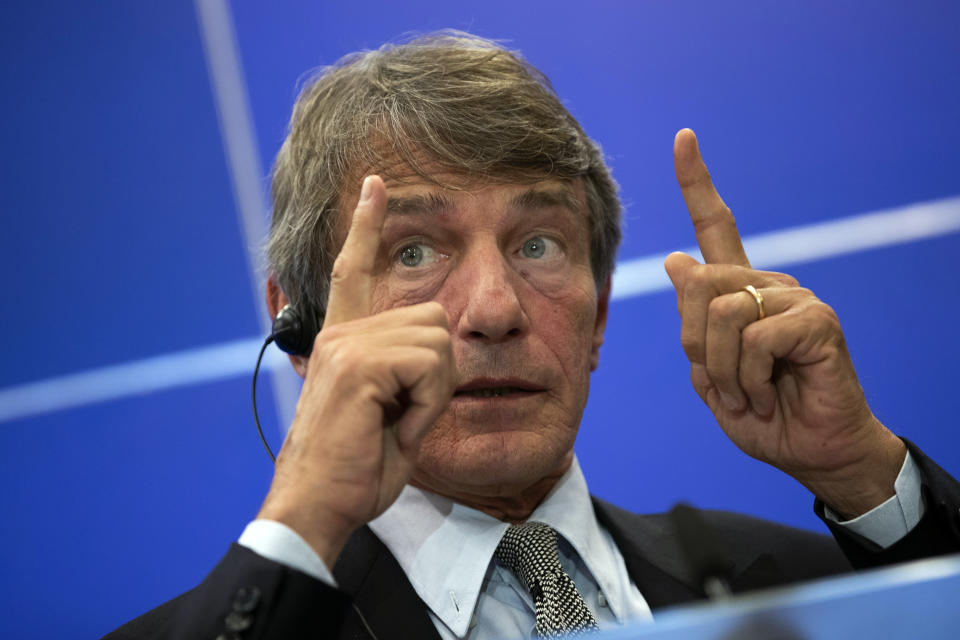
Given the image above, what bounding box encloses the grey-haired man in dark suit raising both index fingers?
[105,34,960,639]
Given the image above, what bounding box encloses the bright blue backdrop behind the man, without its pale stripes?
[0,0,960,638]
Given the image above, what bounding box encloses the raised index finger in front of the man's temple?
[324,176,387,325]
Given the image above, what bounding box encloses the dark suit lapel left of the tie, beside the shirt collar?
[333,527,440,640]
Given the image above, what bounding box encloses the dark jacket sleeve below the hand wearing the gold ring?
[814,439,960,569]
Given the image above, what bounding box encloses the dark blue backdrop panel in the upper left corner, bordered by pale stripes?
[0,2,258,386]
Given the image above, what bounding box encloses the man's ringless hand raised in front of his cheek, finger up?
[257,176,455,567]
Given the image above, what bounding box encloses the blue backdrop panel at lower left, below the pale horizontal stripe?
[0,379,271,638]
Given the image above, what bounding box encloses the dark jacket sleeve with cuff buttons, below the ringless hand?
[104,544,351,640]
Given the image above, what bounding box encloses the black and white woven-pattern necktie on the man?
[495,522,598,638]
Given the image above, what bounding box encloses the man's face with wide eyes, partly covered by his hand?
[344,170,607,497]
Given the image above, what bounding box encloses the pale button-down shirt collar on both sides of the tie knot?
[370,458,623,637]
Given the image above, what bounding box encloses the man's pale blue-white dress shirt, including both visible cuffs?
[239,453,924,640]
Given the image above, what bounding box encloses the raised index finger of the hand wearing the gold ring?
[673,129,750,267]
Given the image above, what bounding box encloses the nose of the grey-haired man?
[456,242,529,343]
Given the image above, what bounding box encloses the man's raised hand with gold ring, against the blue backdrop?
[665,129,906,517]
